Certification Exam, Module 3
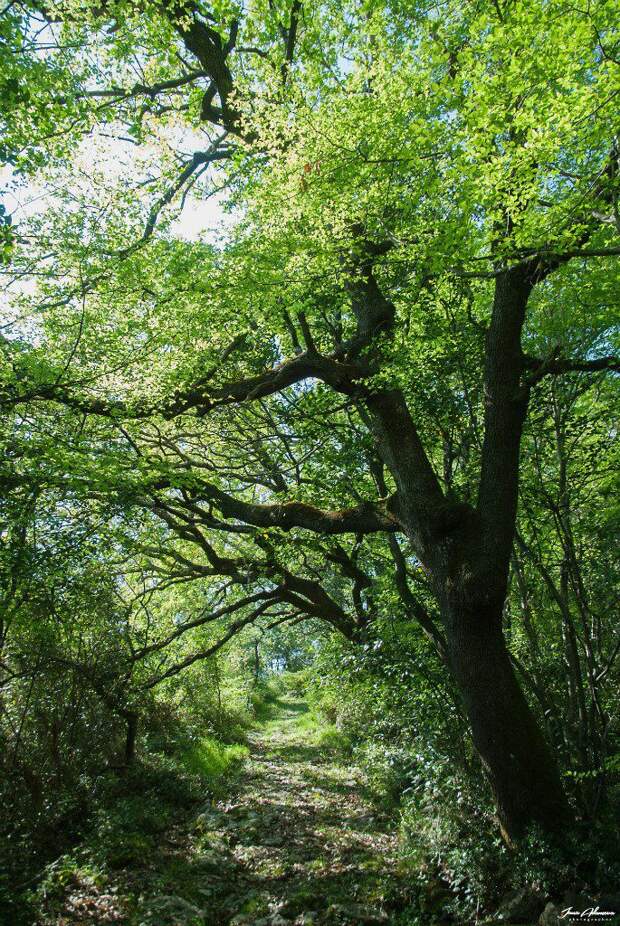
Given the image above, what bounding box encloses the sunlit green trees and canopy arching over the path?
[0,0,620,920]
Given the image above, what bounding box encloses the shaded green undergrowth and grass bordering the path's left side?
[18,736,248,926]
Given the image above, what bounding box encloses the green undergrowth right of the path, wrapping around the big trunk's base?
[308,628,620,924]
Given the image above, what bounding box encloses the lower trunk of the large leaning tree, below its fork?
[444,601,569,843]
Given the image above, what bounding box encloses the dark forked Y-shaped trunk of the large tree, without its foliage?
[367,266,569,841]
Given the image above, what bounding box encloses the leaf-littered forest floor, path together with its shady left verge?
[42,698,406,926]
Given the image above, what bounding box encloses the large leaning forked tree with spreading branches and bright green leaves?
[2,0,620,838]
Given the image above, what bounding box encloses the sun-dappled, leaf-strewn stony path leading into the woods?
[145,700,406,926]
